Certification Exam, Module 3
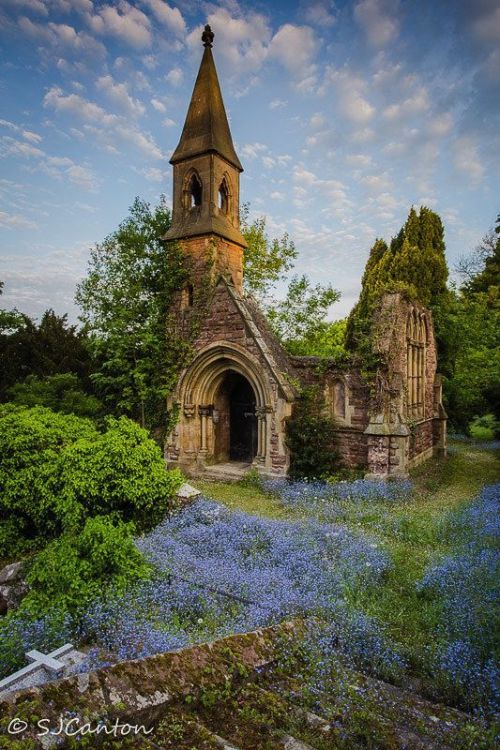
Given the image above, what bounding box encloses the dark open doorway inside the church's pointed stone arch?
[213,370,257,463]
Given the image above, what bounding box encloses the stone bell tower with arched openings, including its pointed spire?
[164,25,246,298]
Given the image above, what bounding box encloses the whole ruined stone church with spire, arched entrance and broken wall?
[165,27,446,477]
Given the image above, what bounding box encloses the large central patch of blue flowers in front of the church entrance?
[74,499,398,676]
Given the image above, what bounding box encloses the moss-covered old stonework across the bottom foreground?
[0,621,489,750]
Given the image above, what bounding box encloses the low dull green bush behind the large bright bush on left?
[8,372,103,418]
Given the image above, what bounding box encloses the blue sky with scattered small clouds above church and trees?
[0,0,500,320]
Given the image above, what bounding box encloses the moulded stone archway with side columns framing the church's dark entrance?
[176,342,273,465]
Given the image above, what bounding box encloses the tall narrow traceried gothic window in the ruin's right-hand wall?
[406,310,427,419]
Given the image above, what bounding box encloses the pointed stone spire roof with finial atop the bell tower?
[170,27,243,172]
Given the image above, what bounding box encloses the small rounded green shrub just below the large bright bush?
[21,516,150,617]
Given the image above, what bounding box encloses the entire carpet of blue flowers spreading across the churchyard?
[0,480,500,716]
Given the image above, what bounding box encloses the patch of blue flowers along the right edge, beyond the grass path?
[417,484,500,713]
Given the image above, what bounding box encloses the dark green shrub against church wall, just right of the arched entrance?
[286,387,338,479]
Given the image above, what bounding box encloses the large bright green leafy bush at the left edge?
[0,404,182,554]
